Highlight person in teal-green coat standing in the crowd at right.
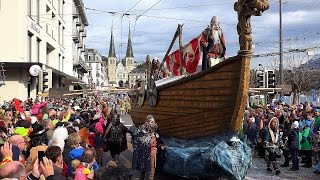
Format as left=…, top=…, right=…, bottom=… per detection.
left=300, top=120, right=312, bottom=168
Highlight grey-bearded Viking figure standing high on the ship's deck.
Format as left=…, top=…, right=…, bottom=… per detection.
left=200, top=16, right=226, bottom=70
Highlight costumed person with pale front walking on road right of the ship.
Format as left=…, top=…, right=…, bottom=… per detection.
left=263, top=117, right=281, bottom=175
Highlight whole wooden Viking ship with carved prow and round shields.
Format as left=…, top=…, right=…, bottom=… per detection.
left=130, top=0, right=269, bottom=139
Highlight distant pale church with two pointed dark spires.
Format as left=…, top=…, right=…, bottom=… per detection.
left=108, top=28, right=135, bottom=86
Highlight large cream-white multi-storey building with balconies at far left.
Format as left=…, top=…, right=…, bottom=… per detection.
left=0, top=0, right=88, bottom=100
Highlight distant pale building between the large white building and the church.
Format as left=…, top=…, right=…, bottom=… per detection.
left=85, top=49, right=106, bottom=90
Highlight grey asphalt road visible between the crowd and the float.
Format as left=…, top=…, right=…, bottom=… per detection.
left=113, top=114, right=320, bottom=180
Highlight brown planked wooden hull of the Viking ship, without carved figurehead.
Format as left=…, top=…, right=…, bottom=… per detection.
left=130, top=56, right=250, bottom=138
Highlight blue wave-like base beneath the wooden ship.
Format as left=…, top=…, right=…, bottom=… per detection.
left=162, top=135, right=252, bottom=179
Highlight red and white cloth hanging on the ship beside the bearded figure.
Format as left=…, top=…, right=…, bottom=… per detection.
left=165, top=36, right=201, bottom=76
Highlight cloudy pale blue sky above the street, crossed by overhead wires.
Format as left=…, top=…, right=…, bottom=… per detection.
left=84, top=0, right=320, bottom=68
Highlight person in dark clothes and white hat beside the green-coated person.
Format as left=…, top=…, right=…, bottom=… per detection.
left=288, top=121, right=300, bottom=171
